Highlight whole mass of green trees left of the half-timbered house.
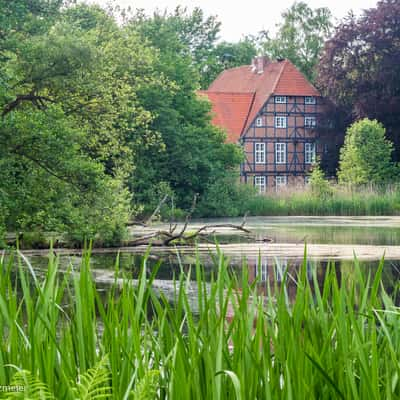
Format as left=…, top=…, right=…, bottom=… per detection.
left=0, top=0, right=241, bottom=242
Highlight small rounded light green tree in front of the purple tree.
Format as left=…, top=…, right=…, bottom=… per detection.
left=338, top=119, right=396, bottom=185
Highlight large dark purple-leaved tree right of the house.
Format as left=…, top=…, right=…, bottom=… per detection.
left=317, top=0, right=400, bottom=161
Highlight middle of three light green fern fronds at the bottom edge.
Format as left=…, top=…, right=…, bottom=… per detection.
left=75, top=357, right=111, bottom=400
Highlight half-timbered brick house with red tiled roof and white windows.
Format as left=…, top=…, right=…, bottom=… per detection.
left=202, top=57, right=323, bottom=192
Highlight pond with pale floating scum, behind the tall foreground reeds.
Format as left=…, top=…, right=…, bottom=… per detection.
left=12, top=217, right=400, bottom=302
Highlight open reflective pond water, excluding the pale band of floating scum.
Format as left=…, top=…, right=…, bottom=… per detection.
left=20, top=217, right=400, bottom=291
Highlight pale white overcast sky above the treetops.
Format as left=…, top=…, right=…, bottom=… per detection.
left=86, top=0, right=377, bottom=41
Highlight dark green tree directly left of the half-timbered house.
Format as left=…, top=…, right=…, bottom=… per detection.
left=130, top=10, right=242, bottom=209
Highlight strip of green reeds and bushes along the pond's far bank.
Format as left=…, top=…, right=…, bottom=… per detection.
left=202, top=184, right=400, bottom=217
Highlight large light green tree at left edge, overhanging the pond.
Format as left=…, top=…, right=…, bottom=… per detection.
left=0, top=1, right=159, bottom=241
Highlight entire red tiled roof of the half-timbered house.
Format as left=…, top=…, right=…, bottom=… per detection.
left=202, top=60, right=321, bottom=141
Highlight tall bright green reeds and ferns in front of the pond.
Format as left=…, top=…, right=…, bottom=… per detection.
left=0, top=254, right=400, bottom=399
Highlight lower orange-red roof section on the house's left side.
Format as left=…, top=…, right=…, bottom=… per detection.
left=199, top=90, right=254, bottom=143
